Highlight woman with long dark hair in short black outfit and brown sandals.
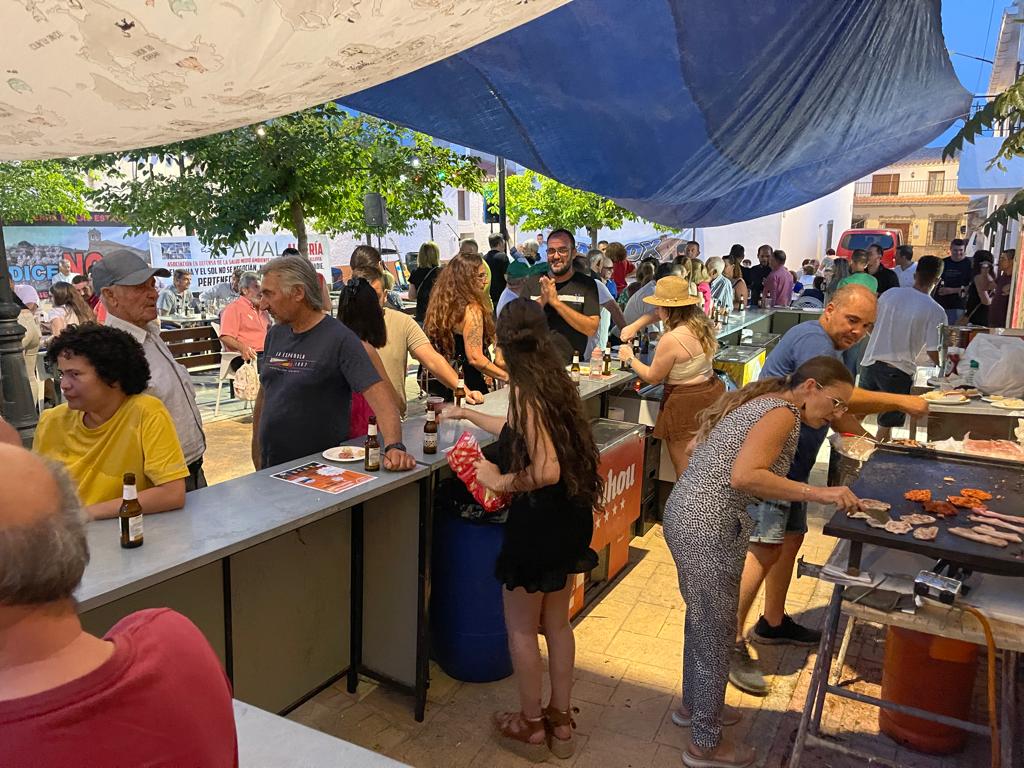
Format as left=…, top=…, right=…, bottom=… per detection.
left=442, top=299, right=603, bottom=758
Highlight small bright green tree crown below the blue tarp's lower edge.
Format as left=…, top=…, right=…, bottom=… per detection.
left=484, top=171, right=638, bottom=246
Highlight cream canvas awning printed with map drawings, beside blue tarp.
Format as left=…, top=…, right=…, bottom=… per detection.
left=0, top=0, right=568, bottom=161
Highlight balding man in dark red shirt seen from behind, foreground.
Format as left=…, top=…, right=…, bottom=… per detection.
left=0, top=444, right=238, bottom=767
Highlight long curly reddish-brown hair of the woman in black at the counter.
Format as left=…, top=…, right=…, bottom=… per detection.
left=423, top=252, right=495, bottom=357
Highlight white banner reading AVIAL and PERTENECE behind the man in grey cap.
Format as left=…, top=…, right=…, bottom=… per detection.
left=150, top=232, right=331, bottom=291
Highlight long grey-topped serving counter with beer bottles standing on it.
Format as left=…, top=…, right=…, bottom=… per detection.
left=76, top=310, right=816, bottom=720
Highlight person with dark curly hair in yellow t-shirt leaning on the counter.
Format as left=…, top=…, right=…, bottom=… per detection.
left=33, top=323, right=188, bottom=519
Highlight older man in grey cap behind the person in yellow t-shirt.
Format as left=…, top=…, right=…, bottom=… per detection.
left=91, top=250, right=206, bottom=490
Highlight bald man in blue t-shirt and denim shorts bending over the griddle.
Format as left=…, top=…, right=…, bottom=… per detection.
left=729, top=284, right=928, bottom=695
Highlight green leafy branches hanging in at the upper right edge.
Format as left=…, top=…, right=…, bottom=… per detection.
left=942, top=82, right=1024, bottom=234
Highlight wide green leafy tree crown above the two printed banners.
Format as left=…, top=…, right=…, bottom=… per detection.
left=83, top=102, right=483, bottom=254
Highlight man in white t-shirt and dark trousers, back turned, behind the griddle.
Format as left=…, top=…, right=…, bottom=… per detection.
left=860, top=256, right=946, bottom=440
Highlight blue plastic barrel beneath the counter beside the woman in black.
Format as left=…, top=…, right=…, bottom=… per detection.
left=430, top=495, right=512, bottom=683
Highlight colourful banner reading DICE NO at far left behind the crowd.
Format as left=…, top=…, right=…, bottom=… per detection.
left=3, top=218, right=150, bottom=298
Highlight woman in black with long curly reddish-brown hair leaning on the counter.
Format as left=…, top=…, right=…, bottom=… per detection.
left=423, top=252, right=508, bottom=399
